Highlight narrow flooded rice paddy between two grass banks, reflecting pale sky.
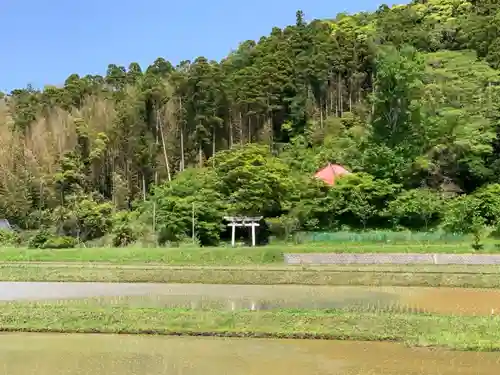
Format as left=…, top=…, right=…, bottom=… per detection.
left=0, top=282, right=500, bottom=315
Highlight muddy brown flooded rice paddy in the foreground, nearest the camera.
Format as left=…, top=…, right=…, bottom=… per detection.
left=0, top=333, right=500, bottom=375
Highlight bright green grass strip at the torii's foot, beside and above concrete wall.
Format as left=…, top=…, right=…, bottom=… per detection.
left=0, top=243, right=494, bottom=266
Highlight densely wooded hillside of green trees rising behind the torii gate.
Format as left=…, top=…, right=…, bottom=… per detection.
left=0, top=0, right=500, bottom=247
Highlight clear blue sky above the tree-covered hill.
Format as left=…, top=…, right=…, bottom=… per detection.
left=0, top=0, right=398, bottom=91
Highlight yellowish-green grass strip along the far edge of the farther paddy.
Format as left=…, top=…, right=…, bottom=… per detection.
left=0, top=264, right=500, bottom=288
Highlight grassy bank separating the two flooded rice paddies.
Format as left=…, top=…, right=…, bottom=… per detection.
left=0, top=303, right=500, bottom=351
